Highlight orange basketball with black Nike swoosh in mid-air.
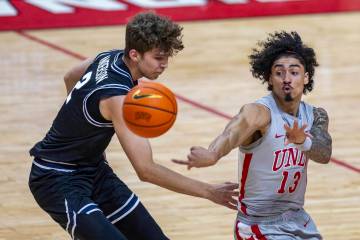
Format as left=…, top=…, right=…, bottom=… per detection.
left=123, top=82, right=177, bottom=138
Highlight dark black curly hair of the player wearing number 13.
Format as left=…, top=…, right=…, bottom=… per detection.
left=249, top=31, right=319, bottom=94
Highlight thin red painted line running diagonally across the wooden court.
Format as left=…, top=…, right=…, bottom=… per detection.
left=16, top=31, right=360, bottom=173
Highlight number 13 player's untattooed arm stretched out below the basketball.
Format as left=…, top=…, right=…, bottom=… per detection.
left=173, top=103, right=271, bottom=169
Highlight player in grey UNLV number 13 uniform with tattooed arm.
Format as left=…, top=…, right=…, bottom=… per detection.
left=173, top=32, right=332, bottom=240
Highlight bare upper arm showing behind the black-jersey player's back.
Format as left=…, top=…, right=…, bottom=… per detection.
left=64, top=58, right=94, bottom=94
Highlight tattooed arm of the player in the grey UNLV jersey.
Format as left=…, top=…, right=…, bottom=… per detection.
left=306, top=108, right=332, bottom=163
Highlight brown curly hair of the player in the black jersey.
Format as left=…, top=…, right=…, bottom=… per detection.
left=124, top=12, right=184, bottom=57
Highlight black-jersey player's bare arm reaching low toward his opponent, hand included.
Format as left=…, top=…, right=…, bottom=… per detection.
left=100, top=96, right=239, bottom=210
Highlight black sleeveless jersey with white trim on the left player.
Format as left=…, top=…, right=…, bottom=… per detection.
left=30, top=50, right=137, bottom=165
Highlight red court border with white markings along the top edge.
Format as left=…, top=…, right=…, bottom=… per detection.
left=0, top=0, right=360, bottom=30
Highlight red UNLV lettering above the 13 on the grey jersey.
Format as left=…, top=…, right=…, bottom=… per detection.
left=272, top=148, right=306, bottom=172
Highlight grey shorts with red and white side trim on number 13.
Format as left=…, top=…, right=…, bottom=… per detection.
left=234, top=209, right=322, bottom=240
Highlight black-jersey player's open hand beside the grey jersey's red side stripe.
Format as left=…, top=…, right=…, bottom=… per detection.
left=208, top=182, right=239, bottom=210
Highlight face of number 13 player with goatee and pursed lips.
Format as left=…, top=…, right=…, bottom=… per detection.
left=269, top=56, right=309, bottom=102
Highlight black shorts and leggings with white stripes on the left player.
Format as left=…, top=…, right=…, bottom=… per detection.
left=29, top=158, right=168, bottom=240
